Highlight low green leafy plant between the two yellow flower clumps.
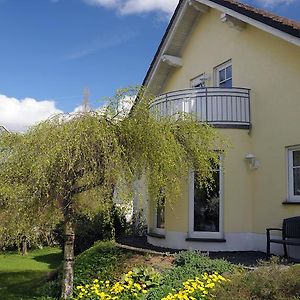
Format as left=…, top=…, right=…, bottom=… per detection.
left=147, top=251, right=236, bottom=300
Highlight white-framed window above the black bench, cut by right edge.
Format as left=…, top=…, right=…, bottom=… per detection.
left=288, top=146, right=300, bottom=202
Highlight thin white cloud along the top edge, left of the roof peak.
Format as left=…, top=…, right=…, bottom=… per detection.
left=84, top=0, right=178, bottom=14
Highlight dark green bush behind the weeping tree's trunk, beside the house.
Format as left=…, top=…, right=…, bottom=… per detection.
left=54, top=207, right=126, bottom=255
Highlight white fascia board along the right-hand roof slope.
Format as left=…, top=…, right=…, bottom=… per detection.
left=195, top=0, right=300, bottom=46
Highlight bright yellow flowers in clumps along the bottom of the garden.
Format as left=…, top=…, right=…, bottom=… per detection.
left=74, top=268, right=227, bottom=300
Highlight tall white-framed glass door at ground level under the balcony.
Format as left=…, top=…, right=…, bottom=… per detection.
left=189, top=162, right=223, bottom=239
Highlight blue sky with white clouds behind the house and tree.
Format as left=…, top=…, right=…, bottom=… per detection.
left=0, top=0, right=300, bottom=130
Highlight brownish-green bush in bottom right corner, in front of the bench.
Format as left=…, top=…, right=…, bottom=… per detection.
left=216, top=262, right=300, bottom=300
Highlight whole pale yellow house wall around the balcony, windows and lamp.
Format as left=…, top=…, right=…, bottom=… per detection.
left=149, top=9, right=300, bottom=233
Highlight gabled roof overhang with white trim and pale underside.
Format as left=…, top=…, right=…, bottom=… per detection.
left=143, top=0, right=300, bottom=94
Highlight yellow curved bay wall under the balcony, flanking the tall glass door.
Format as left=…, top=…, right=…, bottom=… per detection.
left=158, top=129, right=253, bottom=232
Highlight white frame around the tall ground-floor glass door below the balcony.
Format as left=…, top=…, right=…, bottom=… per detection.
left=188, top=155, right=224, bottom=239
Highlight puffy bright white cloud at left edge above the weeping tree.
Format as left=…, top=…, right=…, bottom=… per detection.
left=0, top=94, right=62, bottom=131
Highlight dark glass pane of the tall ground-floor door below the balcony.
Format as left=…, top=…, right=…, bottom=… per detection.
left=194, top=171, right=220, bottom=232
